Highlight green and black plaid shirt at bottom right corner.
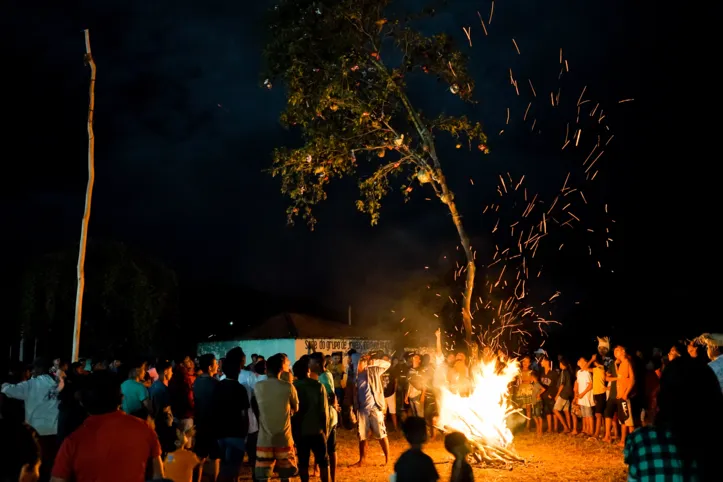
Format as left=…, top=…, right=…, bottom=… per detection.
left=625, top=426, right=697, bottom=482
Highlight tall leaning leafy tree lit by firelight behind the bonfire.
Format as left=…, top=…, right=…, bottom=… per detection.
left=264, top=0, right=489, bottom=342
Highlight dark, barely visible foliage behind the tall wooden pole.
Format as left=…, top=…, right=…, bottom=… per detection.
left=21, top=242, right=177, bottom=355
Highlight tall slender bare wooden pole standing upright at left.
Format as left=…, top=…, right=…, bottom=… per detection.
left=73, top=29, right=96, bottom=362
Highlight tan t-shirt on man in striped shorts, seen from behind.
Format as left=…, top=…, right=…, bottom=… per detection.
left=254, top=378, right=299, bottom=448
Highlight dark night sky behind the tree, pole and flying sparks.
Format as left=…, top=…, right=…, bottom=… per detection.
left=0, top=0, right=700, bottom=350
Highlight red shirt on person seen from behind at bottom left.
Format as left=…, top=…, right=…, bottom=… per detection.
left=52, top=410, right=161, bottom=482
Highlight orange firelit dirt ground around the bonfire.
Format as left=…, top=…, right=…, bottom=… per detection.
left=235, top=430, right=627, bottom=482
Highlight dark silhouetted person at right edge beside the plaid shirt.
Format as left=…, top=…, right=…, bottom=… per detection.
left=655, top=357, right=723, bottom=481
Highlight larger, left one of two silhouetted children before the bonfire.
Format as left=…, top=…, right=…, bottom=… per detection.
left=390, top=417, right=439, bottom=482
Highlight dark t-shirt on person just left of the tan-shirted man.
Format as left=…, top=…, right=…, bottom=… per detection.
left=214, top=378, right=249, bottom=438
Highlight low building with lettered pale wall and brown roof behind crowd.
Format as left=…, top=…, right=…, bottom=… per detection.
left=198, top=313, right=392, bottom=361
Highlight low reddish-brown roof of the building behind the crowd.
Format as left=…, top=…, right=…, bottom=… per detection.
left=239, top=313, right=368, bottom=340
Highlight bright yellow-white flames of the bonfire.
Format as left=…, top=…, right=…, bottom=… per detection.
left=437, top=357, right=520, bottom=449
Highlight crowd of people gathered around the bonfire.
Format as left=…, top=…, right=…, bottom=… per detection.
left=0, top=331, right=723, bottom=482
